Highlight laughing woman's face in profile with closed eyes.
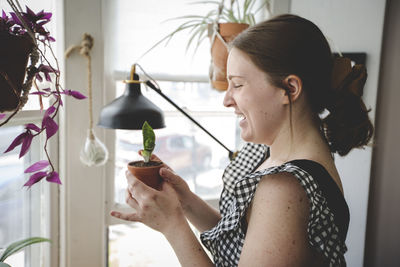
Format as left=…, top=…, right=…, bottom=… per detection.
left=224, top=48, right=287, bottom=145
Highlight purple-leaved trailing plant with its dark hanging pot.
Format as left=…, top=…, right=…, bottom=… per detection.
left=0, top=3, right=86, bottom=187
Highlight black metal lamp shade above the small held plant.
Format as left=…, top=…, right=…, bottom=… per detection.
left=98, top=79, right=165, bottom=130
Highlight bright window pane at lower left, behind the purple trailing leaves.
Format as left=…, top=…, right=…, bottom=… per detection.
left=0, top=118, right=50, bottom=267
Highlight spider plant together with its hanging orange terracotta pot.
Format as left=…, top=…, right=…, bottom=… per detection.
left=143, top=0, right=270, bottom=91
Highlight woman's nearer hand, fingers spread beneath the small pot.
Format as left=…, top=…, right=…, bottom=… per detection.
left=111, top=171, right=186, bottom=234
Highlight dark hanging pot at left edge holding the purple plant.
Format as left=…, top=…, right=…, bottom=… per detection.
left=0, top=32, right=34, bottom=112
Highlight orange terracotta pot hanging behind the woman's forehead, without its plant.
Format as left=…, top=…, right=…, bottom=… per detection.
left=208, top=23, right=249, bottom=91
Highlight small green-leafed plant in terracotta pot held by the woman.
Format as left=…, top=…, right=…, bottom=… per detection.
left=128, top=121, right=164, bottom=190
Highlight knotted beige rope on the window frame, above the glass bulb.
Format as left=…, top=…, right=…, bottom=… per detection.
left=65, top=33, right=94, bottom=140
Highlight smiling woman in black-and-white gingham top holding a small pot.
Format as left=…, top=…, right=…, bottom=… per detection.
left=112, top=15, right=373, bottom=267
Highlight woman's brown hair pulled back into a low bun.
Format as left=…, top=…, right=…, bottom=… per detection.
left=231, top=14, right=374, bottom=156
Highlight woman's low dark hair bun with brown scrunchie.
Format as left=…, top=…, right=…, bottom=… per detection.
left=322, top=58, right=374, bottom=156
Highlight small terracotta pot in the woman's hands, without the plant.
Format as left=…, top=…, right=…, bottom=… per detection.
left=128, top=160, right=164, bottom=190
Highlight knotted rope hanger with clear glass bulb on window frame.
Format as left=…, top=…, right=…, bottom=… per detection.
left=65, top=33, right=108, bottom=166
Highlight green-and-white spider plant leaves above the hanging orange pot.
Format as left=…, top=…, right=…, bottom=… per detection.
left=140, top=0, right=270, bottom=58
